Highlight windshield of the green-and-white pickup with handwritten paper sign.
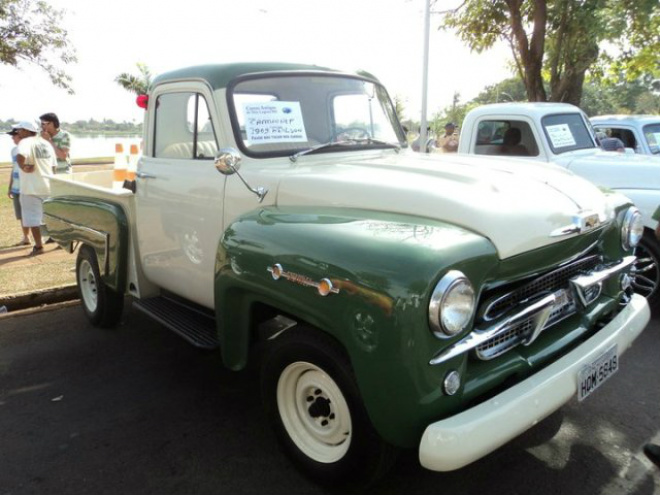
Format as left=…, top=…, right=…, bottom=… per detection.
left=227, top=73, right=405, bottom=157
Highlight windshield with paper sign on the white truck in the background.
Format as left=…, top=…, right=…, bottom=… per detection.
left=541, top=113, right=596, bottom=155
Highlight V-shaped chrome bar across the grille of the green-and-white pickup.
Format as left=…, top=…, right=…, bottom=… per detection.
left=429, top=294, right=557, bottom=366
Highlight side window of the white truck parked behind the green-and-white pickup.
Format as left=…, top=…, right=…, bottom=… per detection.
left=474, top=120, right=539, bottom=156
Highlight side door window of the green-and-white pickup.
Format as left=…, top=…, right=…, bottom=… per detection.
left=154, top=92, right=218, bottom=160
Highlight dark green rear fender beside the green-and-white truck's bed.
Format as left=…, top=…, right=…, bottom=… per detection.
left=44, top=196, right=129, bottom=293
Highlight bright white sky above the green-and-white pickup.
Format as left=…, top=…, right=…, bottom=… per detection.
left=0, top=0, right=511, bottom=122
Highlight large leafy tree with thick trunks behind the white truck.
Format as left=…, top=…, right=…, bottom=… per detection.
left=441, top=0, right=660, bottom=105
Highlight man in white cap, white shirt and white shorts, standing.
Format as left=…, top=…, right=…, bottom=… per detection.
left=12, top=121, right=57, bottom=256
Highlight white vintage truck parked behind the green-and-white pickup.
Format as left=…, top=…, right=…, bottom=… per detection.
left=458, top=103, right=660, bottom=306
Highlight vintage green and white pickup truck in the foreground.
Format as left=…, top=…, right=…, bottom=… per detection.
left=45, top=64, right=649, bottom=483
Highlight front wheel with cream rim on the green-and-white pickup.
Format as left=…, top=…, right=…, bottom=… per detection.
left=261, top=328, right=398, bottom=486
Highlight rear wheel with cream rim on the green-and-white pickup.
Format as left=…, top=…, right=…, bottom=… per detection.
left=76, top=246, right=124, bottom=328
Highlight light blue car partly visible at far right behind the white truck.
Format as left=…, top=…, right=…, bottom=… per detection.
left=591, top=115, right=660, bottom=156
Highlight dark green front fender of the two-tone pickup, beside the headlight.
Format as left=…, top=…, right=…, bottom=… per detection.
left=215, top=208, right=497, bottom=446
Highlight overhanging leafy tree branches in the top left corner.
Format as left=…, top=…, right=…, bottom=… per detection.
left=0, top=0, right=77, bottom=94
